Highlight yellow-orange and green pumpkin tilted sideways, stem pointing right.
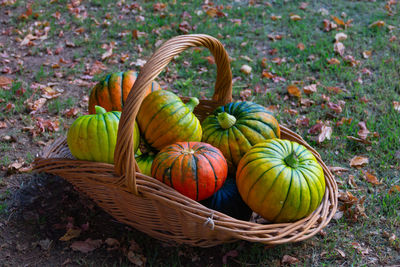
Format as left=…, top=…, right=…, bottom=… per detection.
left=137, top=90, right=202, bottom=151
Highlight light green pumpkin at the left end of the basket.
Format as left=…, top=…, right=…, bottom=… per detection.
left=67, top=106, right=140, bottom=163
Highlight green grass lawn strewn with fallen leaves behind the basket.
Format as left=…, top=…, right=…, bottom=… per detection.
left=0, top=0, right=400, bottom=266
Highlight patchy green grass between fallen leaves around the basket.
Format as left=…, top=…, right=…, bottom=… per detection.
left=0, top=0, right=400, bottom=266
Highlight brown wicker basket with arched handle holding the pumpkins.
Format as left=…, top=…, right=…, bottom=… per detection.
left=34, top=34, right=338, bottom=247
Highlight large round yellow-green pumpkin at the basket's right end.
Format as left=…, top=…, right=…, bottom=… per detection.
left=236, top=139, right=325, bottom=223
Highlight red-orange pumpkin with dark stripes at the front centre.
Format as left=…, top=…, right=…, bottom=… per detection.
left=151, top=142, right=228, bottom=201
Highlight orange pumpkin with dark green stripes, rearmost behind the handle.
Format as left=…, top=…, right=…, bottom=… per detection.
left=89, top=70, right=161, bottom=114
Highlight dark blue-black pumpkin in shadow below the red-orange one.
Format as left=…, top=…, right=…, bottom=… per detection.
left=200, top=178, right=253, bottom=221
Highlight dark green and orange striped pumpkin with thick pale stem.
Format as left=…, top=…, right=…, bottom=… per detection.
left=201, top=102, right=280, bottom=167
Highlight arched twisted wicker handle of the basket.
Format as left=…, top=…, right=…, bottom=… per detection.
left=114, top=34, right=232, bottom=195
